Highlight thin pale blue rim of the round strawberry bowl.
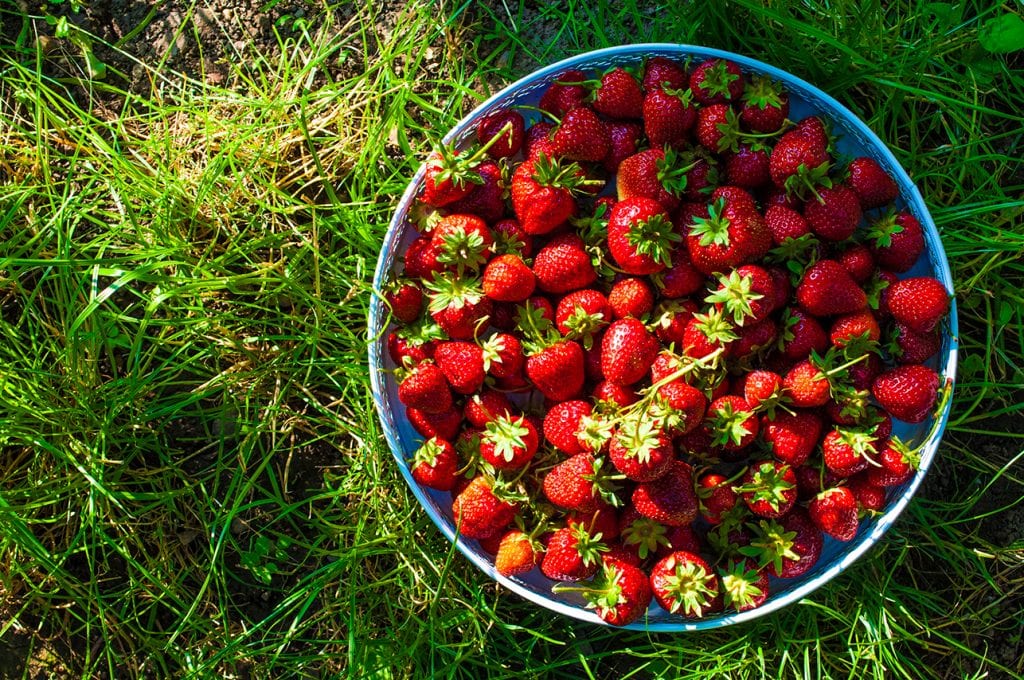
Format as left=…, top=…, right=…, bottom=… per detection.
left=368, top=43, right=958, bottom=633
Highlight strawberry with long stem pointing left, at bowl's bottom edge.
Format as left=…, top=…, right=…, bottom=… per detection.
left=552, top=552, right=651, bottom=626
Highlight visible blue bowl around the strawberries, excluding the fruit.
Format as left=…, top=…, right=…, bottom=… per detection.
left=369, top=43, right=957, bottom=632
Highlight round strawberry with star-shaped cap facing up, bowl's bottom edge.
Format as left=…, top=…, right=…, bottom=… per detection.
left=650, top=550, right=719, bottom=619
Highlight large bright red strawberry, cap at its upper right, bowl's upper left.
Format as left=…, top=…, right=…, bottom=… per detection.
left=512, top=153, right=585, bottom=235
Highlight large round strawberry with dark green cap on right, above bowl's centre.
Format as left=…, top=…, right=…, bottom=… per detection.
left=607, top=196, right=679, bottom=274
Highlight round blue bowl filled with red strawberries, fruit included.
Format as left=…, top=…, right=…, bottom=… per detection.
left=369, top=44, right=956, bottom=631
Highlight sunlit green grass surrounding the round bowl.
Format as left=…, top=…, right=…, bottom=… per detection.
left=0, top=0, right=1024, bottom=678
